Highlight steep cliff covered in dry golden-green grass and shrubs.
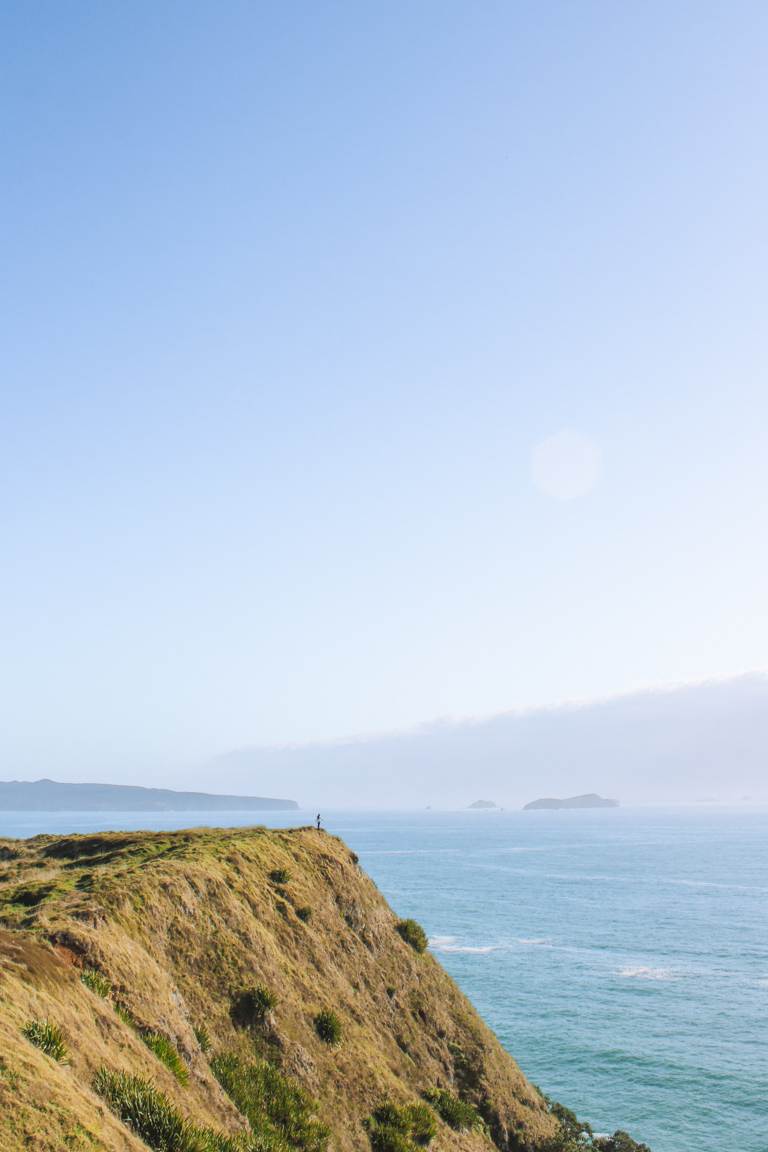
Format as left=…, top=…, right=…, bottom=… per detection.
left=0, top=828, right=649, bottom=1152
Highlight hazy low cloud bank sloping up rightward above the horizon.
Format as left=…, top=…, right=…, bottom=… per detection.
left=202, top=674, right=768, bottom=808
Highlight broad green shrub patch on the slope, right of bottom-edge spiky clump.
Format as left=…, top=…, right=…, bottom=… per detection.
left=211, top=1053, right=330, bottom=1152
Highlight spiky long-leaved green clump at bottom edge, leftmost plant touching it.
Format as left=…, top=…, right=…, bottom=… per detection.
left=93, top=1068, right=249, bottom=1152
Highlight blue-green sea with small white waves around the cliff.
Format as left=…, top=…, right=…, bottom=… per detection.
left=0, top=808, right=768, bottom=1152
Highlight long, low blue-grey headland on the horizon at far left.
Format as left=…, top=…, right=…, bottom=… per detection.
left=0, top=780, right=298, bottom=812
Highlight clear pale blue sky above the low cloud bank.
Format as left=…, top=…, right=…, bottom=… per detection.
left=0, top=0, right=768, bottom=779
